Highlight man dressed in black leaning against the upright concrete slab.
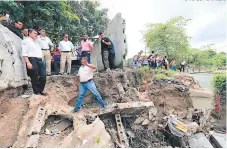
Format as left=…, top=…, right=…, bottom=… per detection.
left=100, top=33, right=115, bottom=71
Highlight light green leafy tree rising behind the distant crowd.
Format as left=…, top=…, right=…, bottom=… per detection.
left=144, top=17, right=189, bottom=61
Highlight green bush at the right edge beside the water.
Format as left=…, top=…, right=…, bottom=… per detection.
left=211, top=73, right=226, bottom=93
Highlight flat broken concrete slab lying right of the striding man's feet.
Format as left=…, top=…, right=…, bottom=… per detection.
left=98, top=102, right=154, bottom=117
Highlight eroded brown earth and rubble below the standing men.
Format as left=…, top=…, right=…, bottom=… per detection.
left=0, top=69, right=224, bottom=147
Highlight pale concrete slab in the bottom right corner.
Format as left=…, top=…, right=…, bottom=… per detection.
left=210, top=131, right=227, bottom=148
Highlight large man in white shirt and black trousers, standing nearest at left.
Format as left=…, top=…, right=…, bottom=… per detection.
left=22, top=29, right=47, bottom=96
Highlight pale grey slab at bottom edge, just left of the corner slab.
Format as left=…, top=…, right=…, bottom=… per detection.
left=188, top=133, right=213, bottom=148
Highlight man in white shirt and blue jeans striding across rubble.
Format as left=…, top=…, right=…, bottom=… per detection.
left=72, top=56, right=106, bottom=113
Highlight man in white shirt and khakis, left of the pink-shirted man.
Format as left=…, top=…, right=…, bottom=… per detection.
left=58, top=34, right=74, bottom=75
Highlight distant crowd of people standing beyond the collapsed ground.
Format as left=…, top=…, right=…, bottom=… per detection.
left=133, top=50, right=186, bottom=72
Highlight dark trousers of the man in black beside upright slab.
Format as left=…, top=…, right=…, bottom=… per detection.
left=102, top=49, right=115, bottom=69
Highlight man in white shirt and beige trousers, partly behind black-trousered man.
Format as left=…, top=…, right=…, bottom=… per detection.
left=37, top=28, right=54, bottom=76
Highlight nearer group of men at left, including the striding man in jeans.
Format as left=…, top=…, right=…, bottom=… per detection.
left=1, top=17, right=115, bottom=112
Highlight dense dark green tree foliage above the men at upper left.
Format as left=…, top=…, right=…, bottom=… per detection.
left=0, top=1, right=109, bottom=43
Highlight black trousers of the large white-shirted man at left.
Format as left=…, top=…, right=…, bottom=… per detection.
left=27, top=57, right=46, bottom=94
